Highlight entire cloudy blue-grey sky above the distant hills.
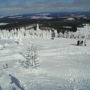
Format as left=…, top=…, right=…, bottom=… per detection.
left=0, top=0, right=90, bottom=16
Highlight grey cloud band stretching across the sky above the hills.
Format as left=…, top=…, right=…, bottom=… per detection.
left=0, top=0, right=90, bottom=15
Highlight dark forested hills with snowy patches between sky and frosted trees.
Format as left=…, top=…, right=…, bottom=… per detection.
left=0, top=11, right=90, bottom=32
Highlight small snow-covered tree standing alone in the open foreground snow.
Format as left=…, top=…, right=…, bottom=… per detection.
left=23, top=45, right=39, bottom=68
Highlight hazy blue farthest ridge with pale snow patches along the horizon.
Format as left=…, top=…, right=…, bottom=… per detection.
left=0, top=11, right=90, bottom=19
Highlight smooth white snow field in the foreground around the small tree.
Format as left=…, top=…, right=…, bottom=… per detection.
left=0, top=38, right=90, bottom=90
